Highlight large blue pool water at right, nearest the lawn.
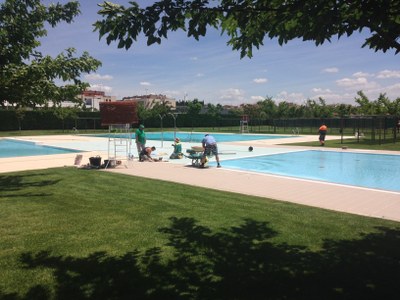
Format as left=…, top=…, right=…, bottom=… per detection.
left=210, top=150, right=400, bottom=192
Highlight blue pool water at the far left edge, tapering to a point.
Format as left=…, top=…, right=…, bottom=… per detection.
left=0, top=139, right=82, bottom=158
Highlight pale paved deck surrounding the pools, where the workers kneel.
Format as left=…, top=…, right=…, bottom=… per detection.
left=0, top=135, right=400, bottom=222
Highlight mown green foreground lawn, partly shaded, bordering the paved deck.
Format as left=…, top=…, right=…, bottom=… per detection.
left=0, top=168, right=400, bottom=299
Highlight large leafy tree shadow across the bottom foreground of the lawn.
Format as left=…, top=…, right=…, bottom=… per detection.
left=0, top=218, right=400, bottom=299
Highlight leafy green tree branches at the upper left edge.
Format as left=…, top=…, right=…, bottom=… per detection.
left=0, top=0, right=101, bottom=107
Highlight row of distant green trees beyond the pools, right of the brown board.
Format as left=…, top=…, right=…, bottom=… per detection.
left=139, top=91, right=400, bottom=127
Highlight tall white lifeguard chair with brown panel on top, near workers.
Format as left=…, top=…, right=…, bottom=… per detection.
left=100, top=101, right=139, bottom=168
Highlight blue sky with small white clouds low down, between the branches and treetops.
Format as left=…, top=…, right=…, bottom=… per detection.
left=39, top=0, right=400, bottom=105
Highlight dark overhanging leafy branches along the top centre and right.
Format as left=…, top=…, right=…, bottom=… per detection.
left=95, top=0, right=400, bottom=57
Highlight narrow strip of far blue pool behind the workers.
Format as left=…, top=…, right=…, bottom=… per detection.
left=90, top=131, right=291, bottom=143
